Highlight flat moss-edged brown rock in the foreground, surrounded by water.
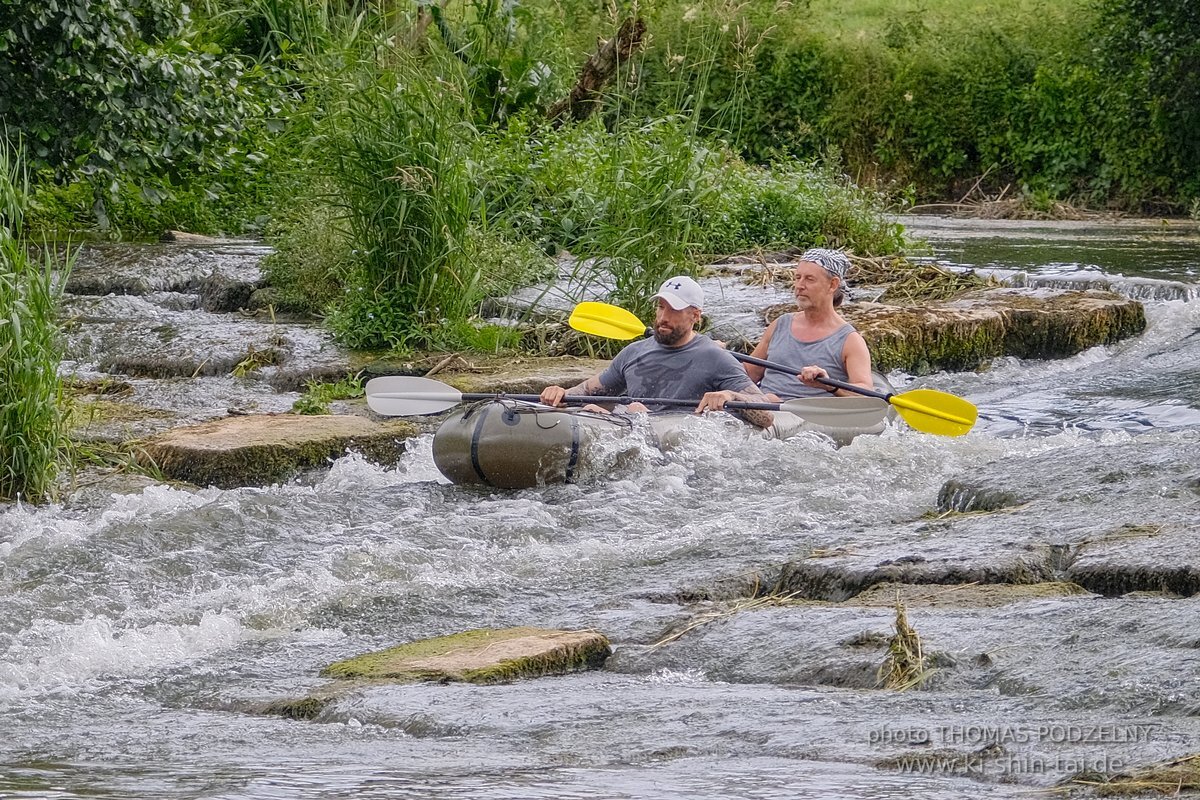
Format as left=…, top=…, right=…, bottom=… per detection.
left=320, top=627, right=611, bottom=684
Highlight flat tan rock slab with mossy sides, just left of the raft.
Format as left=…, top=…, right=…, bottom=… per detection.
left=138, top=414, right=418, bottom=488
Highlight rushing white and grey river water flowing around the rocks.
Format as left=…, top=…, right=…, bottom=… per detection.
left=0, top=218, right=1200, bottom=799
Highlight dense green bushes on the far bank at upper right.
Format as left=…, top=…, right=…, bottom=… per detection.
left=638, top=0, right=1200, bottom=210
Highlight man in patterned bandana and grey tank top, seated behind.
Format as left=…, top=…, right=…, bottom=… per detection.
left=744, top=247, right=874, bottom=402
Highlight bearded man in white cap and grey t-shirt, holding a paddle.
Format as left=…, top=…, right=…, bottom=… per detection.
left=541, top=275, right=773, bottom=428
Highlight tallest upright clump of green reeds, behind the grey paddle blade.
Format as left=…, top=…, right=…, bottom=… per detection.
left=316, top=58, right=480, bottom=348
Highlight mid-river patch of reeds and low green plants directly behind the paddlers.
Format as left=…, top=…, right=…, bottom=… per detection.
left=268, top=56, right=902, bottom=349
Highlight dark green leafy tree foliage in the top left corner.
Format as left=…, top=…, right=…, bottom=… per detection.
left=0, top=0, right=264, bottom=222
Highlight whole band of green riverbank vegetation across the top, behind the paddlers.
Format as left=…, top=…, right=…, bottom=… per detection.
left=0, top=0, right=1200, bottom=349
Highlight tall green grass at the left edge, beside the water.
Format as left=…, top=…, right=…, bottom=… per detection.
left=0, top=136, right=66, bottom=503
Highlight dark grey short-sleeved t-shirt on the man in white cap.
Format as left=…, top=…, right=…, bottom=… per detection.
left=600, top=333, right=754, bottom=411
